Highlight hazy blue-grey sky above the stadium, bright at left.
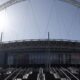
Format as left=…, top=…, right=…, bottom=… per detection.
left=0, top=0, right=80, bottom=41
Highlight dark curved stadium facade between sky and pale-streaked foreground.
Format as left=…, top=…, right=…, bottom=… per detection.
left=0, top=39, right=80, bottom=66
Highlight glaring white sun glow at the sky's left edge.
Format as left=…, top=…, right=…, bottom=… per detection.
left=0, top=11, right=9, bottom=33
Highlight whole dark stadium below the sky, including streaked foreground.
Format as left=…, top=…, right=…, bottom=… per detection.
left=0, top=39, right=80, bottom=80
